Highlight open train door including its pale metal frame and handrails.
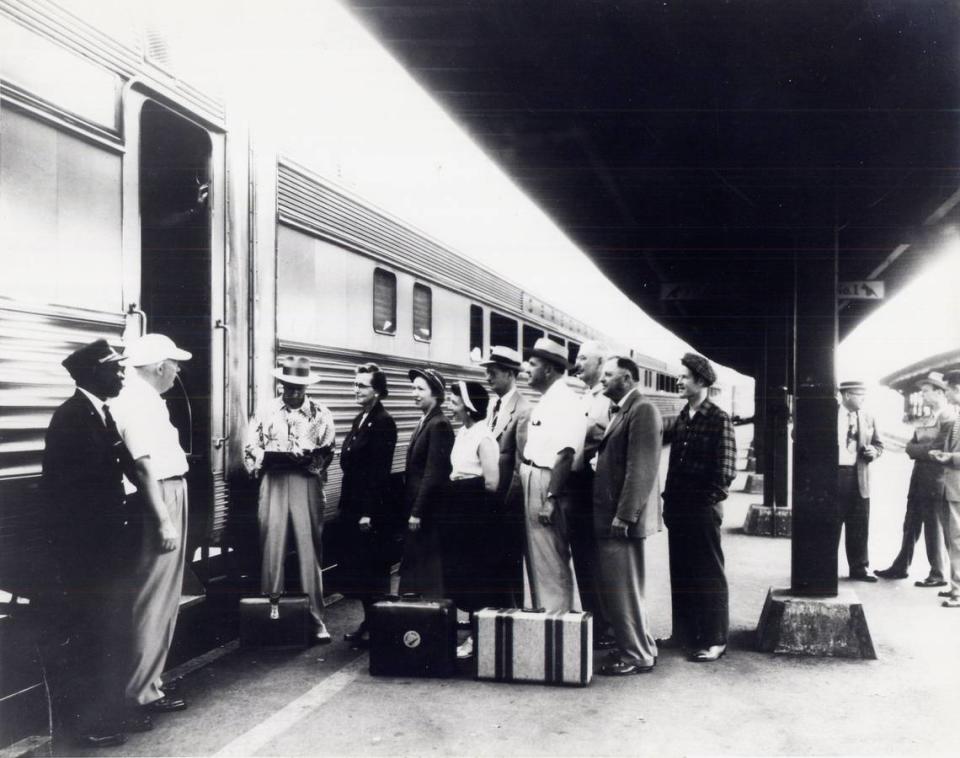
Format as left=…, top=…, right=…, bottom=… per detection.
left=124, top=89, right=229, bottom=595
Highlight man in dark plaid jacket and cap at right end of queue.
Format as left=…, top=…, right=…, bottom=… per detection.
left=662, top=353, right=737, bottom=663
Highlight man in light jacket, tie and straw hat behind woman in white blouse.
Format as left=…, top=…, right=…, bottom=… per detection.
left=480, top=345, right=532, bottom=608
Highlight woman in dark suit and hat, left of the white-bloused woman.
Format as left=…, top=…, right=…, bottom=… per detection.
left=400, top=368, right=453, bottom=598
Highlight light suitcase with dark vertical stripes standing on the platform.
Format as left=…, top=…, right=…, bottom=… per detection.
left=473, top=608, right=593, bottom=686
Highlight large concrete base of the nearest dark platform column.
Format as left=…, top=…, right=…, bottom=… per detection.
left=757, top=587, right=877, bottom=660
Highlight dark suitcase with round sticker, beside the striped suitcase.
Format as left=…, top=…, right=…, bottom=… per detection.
left=367, top=595, right=457, bottom=677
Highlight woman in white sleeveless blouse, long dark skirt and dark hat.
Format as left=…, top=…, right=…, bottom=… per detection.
left=441, top=381, right=500, bottom=658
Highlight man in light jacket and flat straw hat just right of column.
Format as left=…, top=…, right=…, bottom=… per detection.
left=837, top=381, right=883, bottom=582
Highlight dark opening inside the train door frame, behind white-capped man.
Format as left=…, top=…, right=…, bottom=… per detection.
left=139, top=100, right=223, bottom=556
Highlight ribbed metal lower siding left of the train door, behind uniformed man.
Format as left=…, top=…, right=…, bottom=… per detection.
left=0, top=300, right=123, bottom=589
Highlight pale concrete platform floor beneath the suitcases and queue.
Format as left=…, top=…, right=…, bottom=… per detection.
left=73, top=453, right=960, bottom=757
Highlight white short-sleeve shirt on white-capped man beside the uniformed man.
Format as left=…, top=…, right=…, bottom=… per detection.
left=110, top=371, right=189, bottom=479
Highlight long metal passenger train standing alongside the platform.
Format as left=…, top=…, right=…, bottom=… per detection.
left=0, top=0, right=752, bottom=744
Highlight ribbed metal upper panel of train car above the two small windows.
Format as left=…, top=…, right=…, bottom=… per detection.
left=277, top=163, right=523, bottom=320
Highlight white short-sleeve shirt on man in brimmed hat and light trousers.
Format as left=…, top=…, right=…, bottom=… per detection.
left=521, top=379, right=587, bottom=468
